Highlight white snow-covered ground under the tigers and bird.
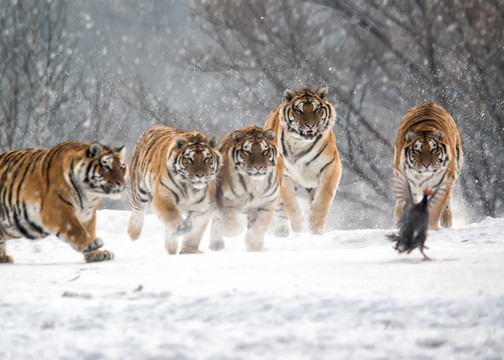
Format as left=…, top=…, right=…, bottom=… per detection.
left=0, top=210, right=504, bottom=360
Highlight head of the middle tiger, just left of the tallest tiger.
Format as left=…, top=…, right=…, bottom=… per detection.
left=231, top=126, right=278, bottom=178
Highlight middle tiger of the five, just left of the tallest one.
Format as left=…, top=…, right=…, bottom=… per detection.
left=210, top=126, right=283, bottom=251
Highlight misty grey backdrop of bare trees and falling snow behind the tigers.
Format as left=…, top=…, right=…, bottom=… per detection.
left=0, top=0, right=504, bottom=230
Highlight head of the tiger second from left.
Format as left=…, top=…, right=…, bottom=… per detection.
left=167, top=131, right=221, bottom=189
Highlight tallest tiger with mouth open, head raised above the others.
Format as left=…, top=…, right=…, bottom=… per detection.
left=264, top=87, right=341, bottom=236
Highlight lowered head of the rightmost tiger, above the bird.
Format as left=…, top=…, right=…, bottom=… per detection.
left=404, top=130, right=449, bottom=173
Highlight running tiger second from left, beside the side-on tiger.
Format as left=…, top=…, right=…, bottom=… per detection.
left=128, top=125, right=222, bottom=255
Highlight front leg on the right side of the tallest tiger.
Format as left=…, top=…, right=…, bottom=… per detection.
left=309, top=159, right=341, bottom=235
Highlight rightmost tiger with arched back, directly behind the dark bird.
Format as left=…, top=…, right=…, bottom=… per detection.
left=394, top=103, right=463, bottom=229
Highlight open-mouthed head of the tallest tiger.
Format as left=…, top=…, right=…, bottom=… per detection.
left=283, top=87, right=336, bottom=140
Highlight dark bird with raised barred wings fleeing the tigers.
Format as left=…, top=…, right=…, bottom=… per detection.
left=387, top=169, right=447, bottom=260
